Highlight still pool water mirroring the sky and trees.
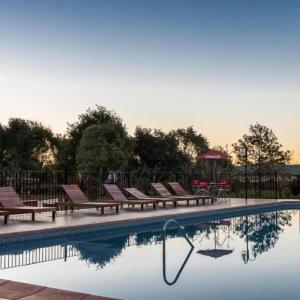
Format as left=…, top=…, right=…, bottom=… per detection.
left=0, top=210, right=300, bottom=300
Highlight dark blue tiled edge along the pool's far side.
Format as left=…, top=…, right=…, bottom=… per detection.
left=0, top=200, right=300, bottom=244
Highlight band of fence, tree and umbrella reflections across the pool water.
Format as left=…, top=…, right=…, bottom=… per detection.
left=0, top=211, right=293, bottom=270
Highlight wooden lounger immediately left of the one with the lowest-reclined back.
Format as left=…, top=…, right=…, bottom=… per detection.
left=103, top=184, right=158, bottom=210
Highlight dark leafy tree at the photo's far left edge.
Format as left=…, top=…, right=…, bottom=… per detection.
left=0, top=118, right=56, bottom=169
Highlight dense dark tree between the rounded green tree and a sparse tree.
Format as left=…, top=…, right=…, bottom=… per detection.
left=135, top=127, right=191, bottom=172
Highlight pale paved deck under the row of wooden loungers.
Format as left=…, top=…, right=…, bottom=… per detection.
left=0, top=199, right=300, bottom=237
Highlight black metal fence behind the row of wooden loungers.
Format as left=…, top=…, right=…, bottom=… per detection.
left=0, top=170, right=288, bottom=204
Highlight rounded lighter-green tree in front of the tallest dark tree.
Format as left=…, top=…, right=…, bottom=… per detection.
left=76, top=122, right=132, bottom=170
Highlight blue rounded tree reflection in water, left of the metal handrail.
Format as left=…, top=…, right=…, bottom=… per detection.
left=74, top=236, right=128, bottom=269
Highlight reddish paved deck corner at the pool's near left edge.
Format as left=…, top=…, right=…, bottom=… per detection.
left=0, top=279, right=116, bottom=300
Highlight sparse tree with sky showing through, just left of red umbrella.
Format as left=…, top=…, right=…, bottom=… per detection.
left=170, top=126, right=209, bottom=162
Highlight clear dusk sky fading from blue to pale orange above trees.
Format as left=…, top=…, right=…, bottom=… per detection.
left=0, top=0, right=300, bottom=163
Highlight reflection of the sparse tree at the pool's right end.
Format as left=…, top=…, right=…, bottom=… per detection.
left=235, top=211, right=292, bottom=262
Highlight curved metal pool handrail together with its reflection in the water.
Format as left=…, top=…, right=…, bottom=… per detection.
left=163, top=219, right=194, bottom=285
